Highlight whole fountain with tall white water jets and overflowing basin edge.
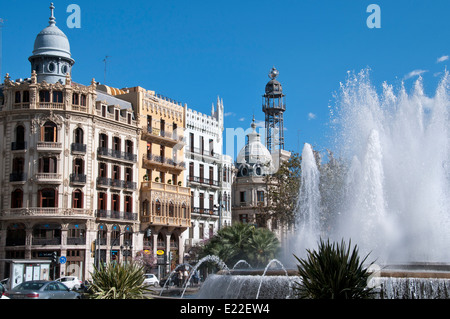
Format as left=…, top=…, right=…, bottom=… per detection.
left=180, top=70, right=450, bottom=299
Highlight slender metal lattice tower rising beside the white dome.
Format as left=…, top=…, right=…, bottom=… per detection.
left=262, top=67, right=286, bottom=153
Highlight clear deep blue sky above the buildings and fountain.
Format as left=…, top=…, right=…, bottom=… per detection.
left=0, top=0, right=450, bottom=160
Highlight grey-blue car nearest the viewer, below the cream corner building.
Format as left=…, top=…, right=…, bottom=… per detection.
left=6, top=280, right=81, bottom=299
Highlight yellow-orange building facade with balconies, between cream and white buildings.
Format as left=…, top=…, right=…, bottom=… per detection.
left=101, top=86, right=191, bottom=270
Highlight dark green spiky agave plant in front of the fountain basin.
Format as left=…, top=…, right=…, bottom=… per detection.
left=294, top=239, right=373, bottom=299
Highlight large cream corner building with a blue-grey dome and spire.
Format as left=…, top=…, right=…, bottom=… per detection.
left=0, top=4, right=142, bottom=280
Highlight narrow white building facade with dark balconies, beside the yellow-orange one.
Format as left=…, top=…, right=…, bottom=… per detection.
left=184, top=98, right=233, bottom=252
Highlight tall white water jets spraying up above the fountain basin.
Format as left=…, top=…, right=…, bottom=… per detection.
left=298, top=70, right=450, bottom=262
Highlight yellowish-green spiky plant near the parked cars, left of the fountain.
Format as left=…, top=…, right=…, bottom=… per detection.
left=91, top=263, right=151, bottom=299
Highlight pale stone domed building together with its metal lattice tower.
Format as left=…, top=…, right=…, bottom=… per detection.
left=232, top=68, right=291, bottom=237
